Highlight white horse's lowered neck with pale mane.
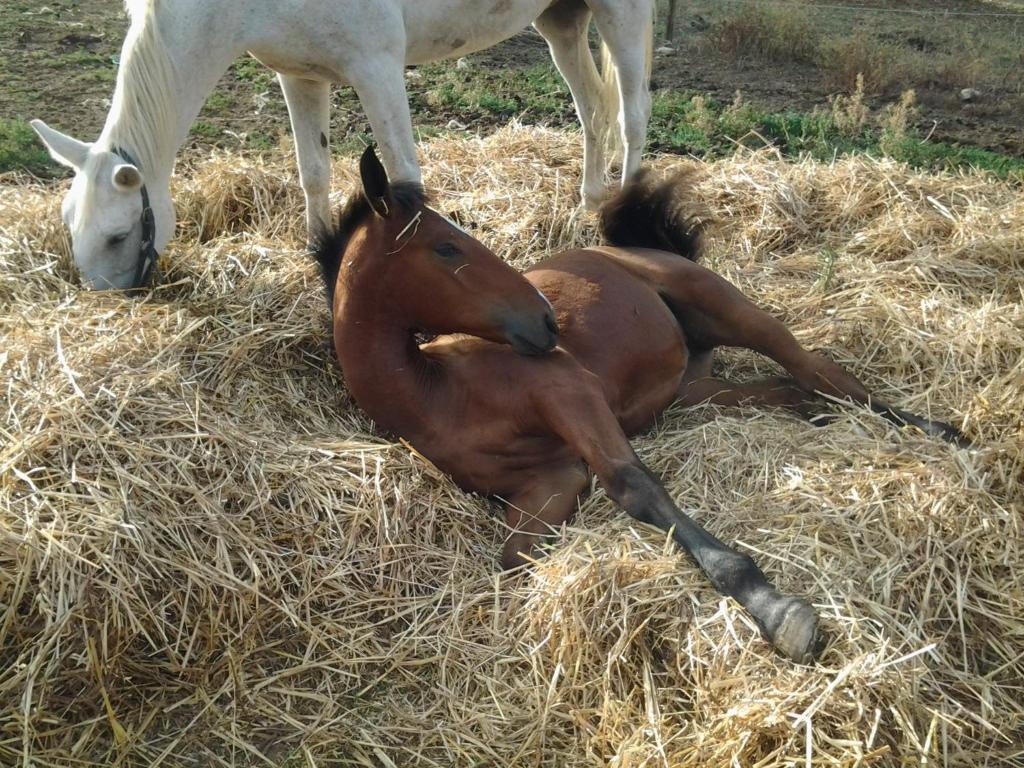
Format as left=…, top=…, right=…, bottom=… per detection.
left=97, top=0, right=237, bottom=184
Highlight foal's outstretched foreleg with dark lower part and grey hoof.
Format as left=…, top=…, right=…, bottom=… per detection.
left=537, top=371, right=820, bottom=664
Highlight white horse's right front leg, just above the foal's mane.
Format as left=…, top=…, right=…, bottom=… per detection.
left=347, top=56, right=422, bottom=183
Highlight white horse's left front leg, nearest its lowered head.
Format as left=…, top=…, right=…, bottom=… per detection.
left=278, top=75, right=331, bottom=243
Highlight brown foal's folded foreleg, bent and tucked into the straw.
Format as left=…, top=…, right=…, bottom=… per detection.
left=502, top=461, right=590, bottom=570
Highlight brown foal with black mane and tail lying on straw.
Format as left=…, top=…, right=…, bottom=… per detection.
left=316, top=148, right=963, bottom=663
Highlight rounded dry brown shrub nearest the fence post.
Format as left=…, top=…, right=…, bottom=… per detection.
left=708, top=3, right=821, bottom=63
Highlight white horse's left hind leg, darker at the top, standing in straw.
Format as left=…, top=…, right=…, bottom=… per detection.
left=534, top=2, right=608, bottom=210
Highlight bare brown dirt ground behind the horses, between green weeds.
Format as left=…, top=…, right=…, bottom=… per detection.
left=0, top=0, right=1024, bottom=167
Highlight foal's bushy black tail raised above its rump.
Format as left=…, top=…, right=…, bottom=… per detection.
left=598, top=168, right=705, bottom=261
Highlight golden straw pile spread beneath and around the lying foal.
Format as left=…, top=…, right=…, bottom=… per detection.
left=0, top=128, right=1024, bottom=768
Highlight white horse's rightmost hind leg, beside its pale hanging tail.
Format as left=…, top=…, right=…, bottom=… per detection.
left=589, top=0, right=652, bottom=183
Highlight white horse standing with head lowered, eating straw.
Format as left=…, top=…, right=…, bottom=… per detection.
left=32, top=0, right=653, bottom=289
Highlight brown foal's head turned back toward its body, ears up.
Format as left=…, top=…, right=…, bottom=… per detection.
left=316, top=147, right=558, bottom=354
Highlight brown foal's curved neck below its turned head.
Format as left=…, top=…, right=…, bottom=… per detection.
left=334, top=262, right=444, bottom=441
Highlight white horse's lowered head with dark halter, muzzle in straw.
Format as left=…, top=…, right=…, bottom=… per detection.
left=32, top=120, right=175, bottom=289
